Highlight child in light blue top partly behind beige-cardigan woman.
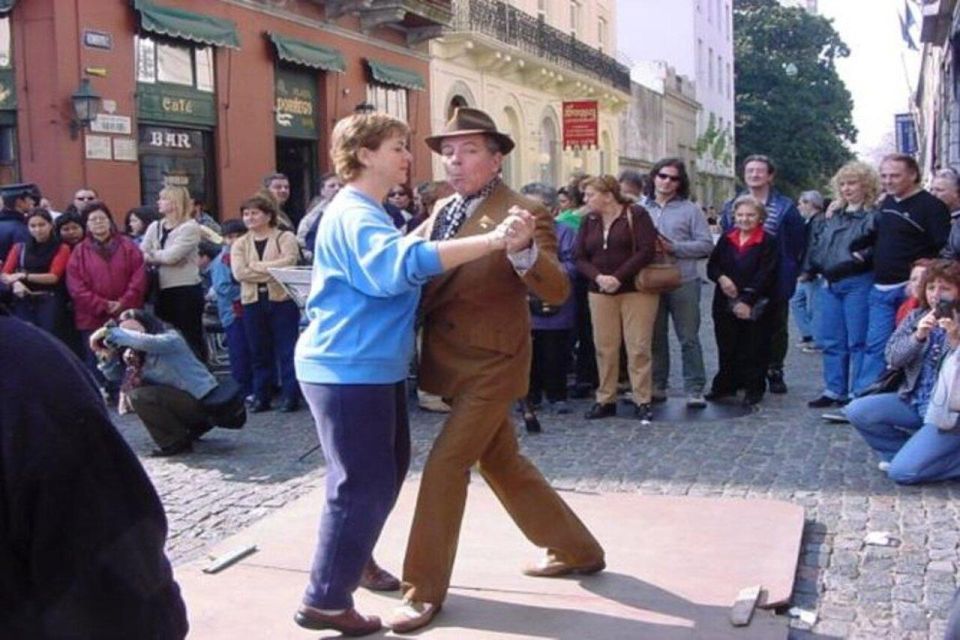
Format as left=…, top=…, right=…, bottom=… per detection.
left=209, top=220, right=253, bottom=396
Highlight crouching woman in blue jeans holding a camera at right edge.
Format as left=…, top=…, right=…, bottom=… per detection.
left=845, top=260, right=960, bottom=484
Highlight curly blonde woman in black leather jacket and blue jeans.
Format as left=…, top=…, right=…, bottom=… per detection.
left=804, top=162, right=880, bottom=408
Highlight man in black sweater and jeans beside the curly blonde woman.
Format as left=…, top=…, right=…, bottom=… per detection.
left=853, top=153, right=950, bottom=389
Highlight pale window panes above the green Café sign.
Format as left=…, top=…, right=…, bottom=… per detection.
left=136, top=36, right=214, bottom=93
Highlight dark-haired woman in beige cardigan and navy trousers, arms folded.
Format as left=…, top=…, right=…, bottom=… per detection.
left=230, top=195, right=300, bottom=413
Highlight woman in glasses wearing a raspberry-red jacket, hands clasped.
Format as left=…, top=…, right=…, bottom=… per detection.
left=67, top=201, right=147, bottom=386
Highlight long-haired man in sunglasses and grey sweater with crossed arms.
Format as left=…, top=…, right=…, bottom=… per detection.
left=642, top=158, right=713, bottom=408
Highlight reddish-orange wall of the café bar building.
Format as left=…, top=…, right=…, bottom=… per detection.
left=12, top=0, right=430, bottom=217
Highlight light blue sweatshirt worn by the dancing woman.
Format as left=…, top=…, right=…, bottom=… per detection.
left=295, top=185, right=443, bottom=384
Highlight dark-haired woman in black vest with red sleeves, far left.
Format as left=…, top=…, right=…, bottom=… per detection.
left=0, top=208, right=70, bottom=340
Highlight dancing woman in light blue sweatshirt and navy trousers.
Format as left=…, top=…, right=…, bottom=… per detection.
left=295, top=113, right=534, bottom=636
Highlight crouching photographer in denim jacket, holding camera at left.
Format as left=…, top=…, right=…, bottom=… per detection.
left=90, top=309, right=217, bottom=457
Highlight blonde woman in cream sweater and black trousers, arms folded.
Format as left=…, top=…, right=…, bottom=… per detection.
left=140, top=187, right=207, bottom=362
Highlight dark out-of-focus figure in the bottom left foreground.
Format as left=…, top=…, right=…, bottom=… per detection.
left=0, top=311, right=187, bottom=640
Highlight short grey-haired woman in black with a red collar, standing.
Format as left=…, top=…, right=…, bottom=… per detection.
left=707, top=196, right=779, bottom=405
